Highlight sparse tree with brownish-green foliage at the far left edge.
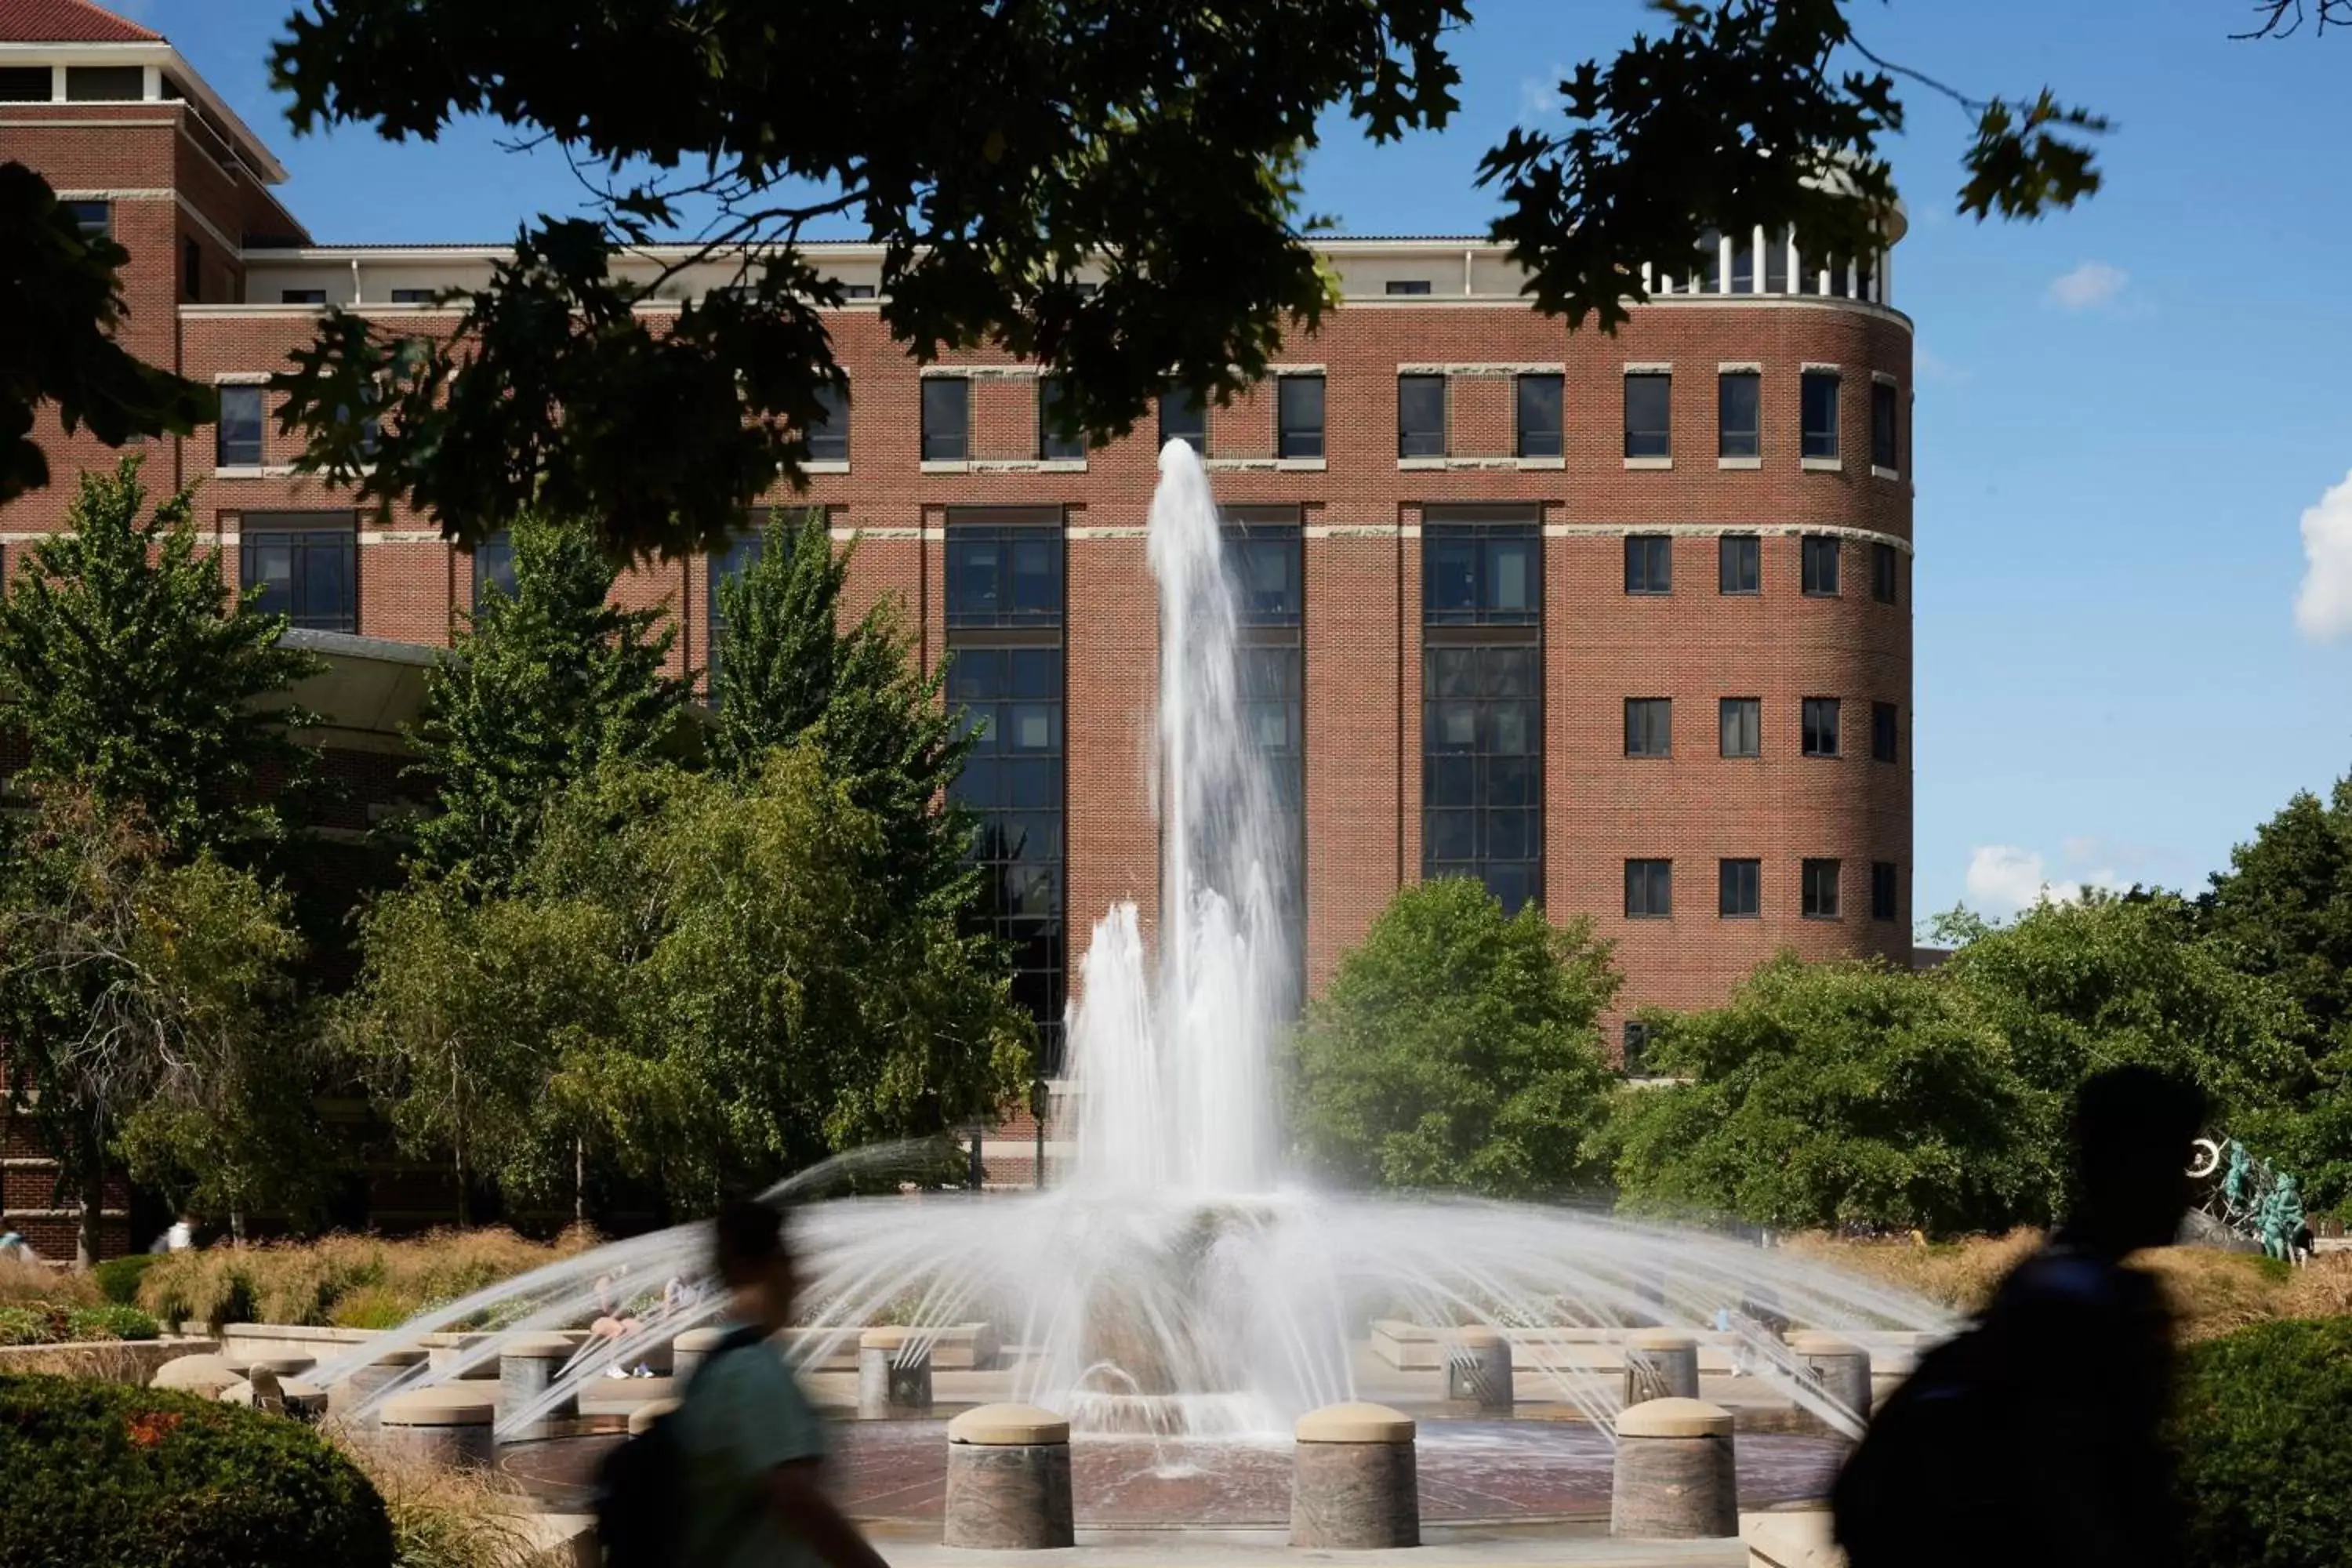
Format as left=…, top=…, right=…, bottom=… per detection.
left=0, top=785, right=299, bottom=1262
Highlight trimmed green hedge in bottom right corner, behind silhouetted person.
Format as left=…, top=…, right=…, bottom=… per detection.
left=2173, top=1316, right=2352, bottom=1568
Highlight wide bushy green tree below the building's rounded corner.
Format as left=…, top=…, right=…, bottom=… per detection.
left=1609, top=954, right=2051, bottom=1234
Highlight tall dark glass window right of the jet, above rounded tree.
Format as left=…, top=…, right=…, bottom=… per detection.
left=1421, top=508, right=1543, bottom=909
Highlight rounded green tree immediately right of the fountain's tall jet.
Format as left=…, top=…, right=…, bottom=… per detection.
left=1296, top=877, right=1618, bottom=1199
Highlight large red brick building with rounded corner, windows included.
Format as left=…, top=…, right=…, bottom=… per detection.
left=0, top=0, right=1912, bottom=1213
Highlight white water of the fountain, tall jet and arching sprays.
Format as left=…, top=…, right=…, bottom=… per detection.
left=318, top=442, right=1947, bottom=1521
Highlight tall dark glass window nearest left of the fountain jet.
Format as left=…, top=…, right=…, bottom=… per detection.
left=948, top=508, right=1068, bottom=1076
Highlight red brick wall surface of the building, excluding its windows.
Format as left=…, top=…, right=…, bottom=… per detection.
left=0, top=21, right=1912, bottom=1213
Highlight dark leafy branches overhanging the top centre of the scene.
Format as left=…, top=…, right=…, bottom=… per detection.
left=270, top=0, right=2100, bottom=553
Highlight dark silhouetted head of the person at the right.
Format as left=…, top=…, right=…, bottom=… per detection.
left=2067, top=1065, right=2206, bottom=1255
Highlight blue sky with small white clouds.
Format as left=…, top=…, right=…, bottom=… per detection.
left=118, top=0, right=2352, bottom=914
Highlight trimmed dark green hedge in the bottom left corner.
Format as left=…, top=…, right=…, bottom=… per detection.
left=0, top=1377, right=393, bottom=1568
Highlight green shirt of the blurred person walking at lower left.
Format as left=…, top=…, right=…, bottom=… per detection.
left=677, top=1345, right=826, bottom=1568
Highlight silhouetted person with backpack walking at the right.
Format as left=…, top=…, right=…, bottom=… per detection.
left=1835, top=1067, right=2204, bottom=1568
